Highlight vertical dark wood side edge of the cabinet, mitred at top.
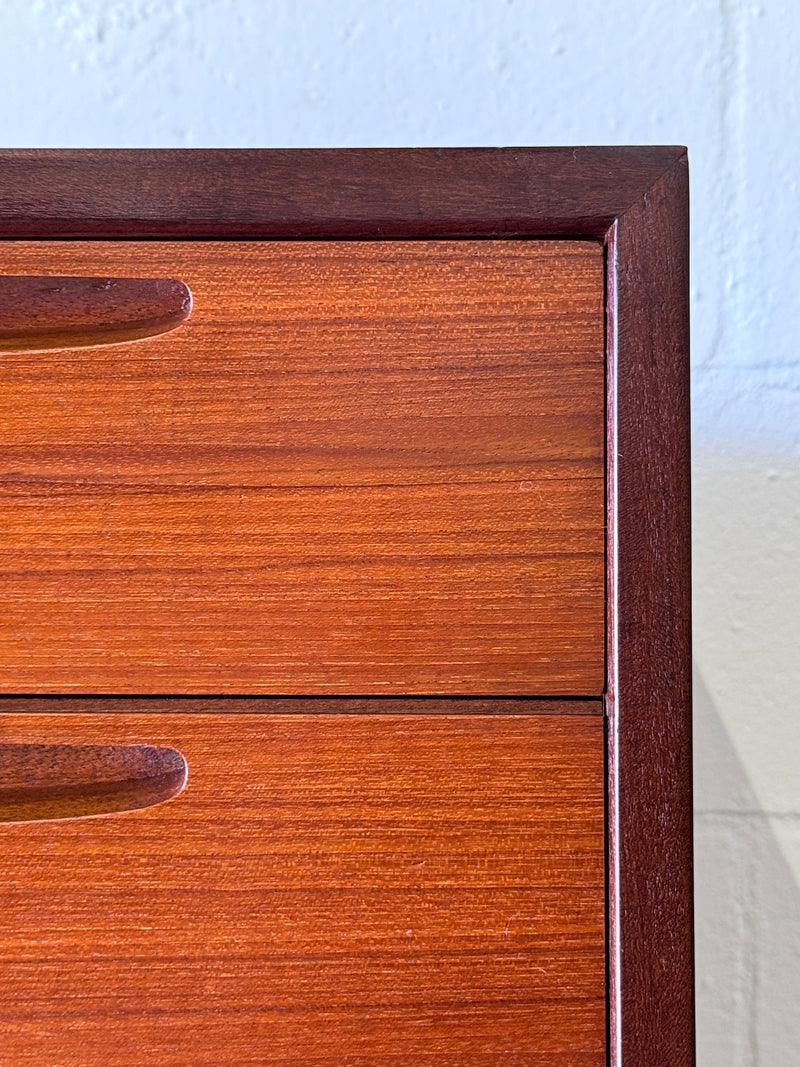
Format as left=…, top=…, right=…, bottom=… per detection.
left=606, top=152, right=694, bottom=1067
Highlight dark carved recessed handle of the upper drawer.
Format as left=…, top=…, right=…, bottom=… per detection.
left=0, top=275, right=192, bottom=351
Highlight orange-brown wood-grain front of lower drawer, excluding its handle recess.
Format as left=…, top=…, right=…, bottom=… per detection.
left=0, top=714, right=606, bottom=1067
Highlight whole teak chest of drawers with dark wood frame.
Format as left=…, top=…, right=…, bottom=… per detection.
left=0, top=148, right=693, bottom=1067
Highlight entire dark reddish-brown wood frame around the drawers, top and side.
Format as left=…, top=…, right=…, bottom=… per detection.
left=0, top=147, right=694, bottom=1067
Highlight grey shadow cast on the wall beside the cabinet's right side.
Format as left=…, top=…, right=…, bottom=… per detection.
left=694, top=673, right=800, bottom=1067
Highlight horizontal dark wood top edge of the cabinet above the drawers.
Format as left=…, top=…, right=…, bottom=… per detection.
left=0, top=147, right=682, bottom=240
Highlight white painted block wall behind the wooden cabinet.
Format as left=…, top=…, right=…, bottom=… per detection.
left=0, top=0, right=800, bottom=1067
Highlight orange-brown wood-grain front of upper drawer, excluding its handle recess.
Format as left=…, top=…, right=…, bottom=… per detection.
left=0, top=241, right=605, bottom=695
